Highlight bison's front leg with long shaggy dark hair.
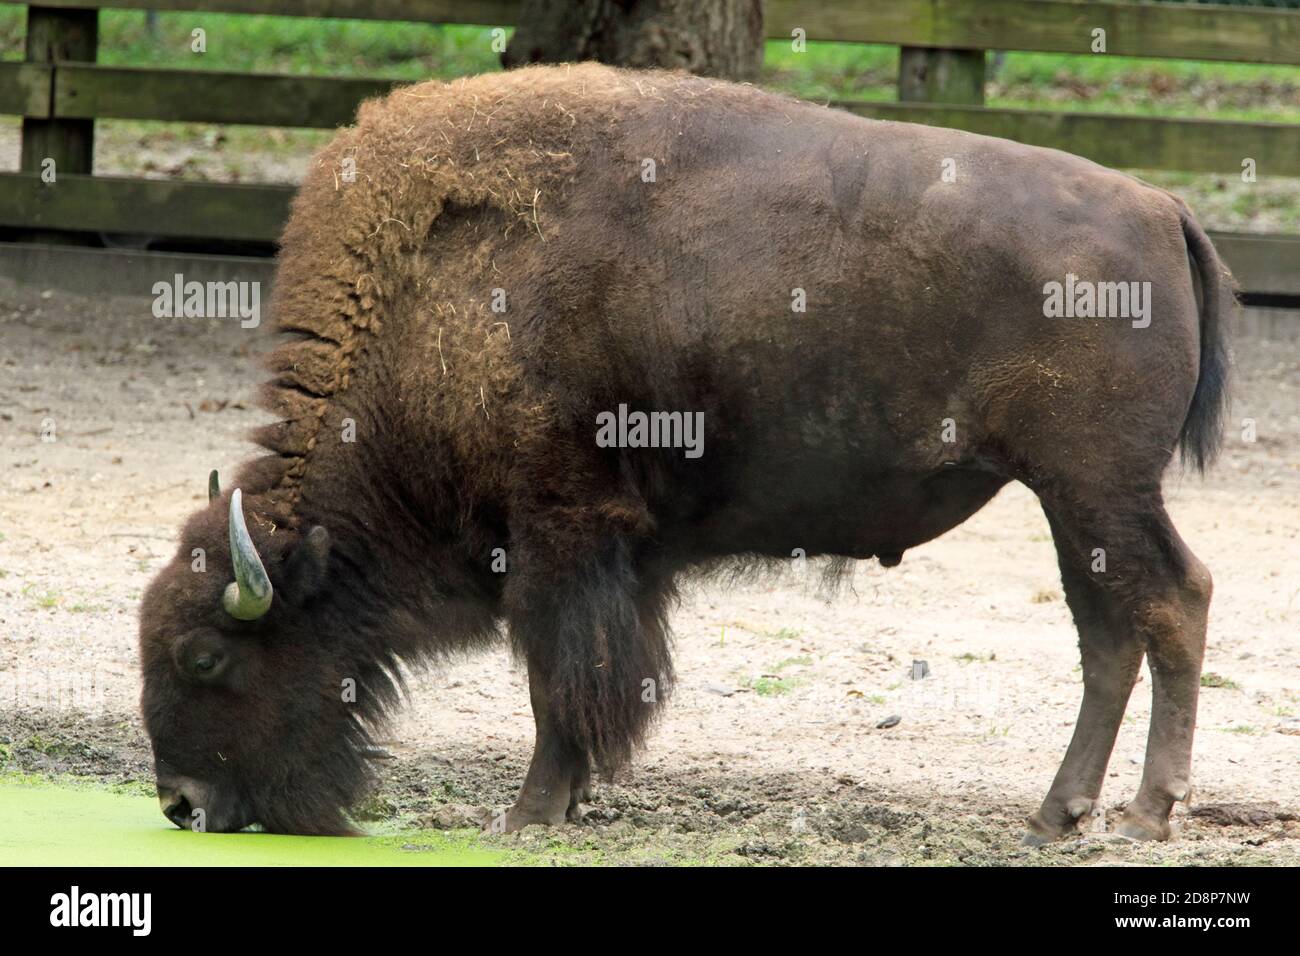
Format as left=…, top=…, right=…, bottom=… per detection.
left=506, top=524, right=671, bottom=830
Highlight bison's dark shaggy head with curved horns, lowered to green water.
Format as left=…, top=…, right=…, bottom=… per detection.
left=140, top=473, right=369, bottom=834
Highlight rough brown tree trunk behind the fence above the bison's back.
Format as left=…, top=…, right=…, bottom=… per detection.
left=501, top=0, right=763, bottom=81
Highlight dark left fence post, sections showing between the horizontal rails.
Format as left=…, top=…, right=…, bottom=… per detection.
left=20, top=7, right=99, bottom=176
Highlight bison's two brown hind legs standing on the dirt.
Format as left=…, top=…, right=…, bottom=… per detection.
left=1026, top=483, right=1210, bottom=843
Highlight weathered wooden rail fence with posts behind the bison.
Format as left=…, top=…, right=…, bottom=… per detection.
left=0, top=0, right=1300, bottom=297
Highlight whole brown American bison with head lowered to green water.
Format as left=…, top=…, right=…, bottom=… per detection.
left=140, top=65, right=1234, bottom=842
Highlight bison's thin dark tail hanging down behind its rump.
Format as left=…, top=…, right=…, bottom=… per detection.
left=1178, top=204, right=1236, bottom=472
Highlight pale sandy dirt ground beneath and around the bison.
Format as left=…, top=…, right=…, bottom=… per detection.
left=0, top=286, right=1300, bottom=865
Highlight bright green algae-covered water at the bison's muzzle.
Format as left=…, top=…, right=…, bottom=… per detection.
left=0, top=778, right=504, bottom=866
